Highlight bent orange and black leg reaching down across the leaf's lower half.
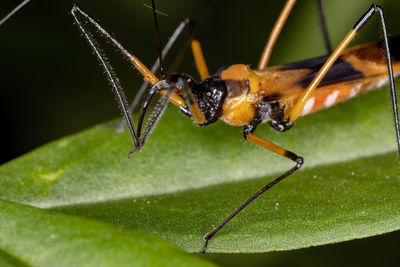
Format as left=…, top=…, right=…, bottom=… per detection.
left=203, top=127, right=303, bottom=253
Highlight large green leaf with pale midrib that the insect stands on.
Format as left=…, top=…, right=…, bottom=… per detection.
left=0, top=88, right=400, bottom=252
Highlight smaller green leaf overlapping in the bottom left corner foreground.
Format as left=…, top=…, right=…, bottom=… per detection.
left=0, top=201, right=216, bottom=266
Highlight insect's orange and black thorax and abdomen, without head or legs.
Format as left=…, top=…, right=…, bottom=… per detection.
left=195, top=38, right=400, bottom=130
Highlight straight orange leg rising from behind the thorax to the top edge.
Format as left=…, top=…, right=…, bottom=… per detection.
left=257, top=0, right=296, bottom=70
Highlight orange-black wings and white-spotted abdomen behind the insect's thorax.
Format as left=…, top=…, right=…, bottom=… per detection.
left=265, top=38, right=400, bottom=118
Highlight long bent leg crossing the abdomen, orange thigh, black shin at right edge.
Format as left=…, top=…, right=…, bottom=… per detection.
left=287, top=4, right=400, bottom=155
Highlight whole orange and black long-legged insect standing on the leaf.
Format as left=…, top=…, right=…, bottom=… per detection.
left=71, top=0, right=400, bottom=252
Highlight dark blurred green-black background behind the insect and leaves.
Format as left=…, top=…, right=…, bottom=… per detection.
left=0, top=0, right=400, bottom=266
